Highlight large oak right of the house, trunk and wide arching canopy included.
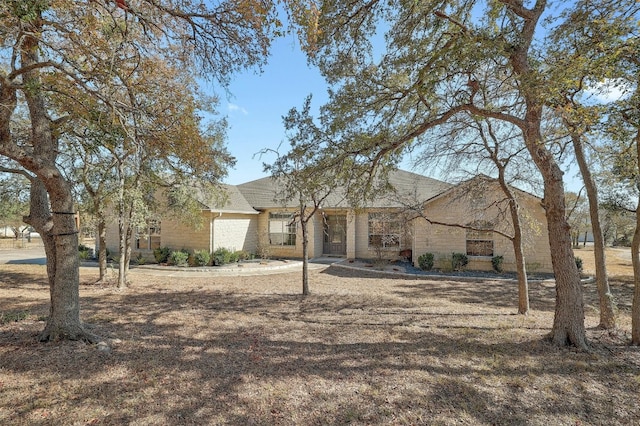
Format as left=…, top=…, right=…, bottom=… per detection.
left=292, top=0, right=638, bottom=348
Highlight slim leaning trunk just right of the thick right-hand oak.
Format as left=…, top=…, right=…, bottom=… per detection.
left=571, top=134, right=616, bottom=330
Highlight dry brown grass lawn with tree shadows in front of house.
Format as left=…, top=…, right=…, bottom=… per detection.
left=0, top=249, right=640, bottom=426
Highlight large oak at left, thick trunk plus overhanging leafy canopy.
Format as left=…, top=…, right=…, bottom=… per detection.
left=0, top=0, right=300, bottom=341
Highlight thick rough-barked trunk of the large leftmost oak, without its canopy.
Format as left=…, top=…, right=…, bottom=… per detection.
left=18, top=24, right=97, bottom=342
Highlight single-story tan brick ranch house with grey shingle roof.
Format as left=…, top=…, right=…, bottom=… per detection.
left=107, top=170, right=552, bottom=272
